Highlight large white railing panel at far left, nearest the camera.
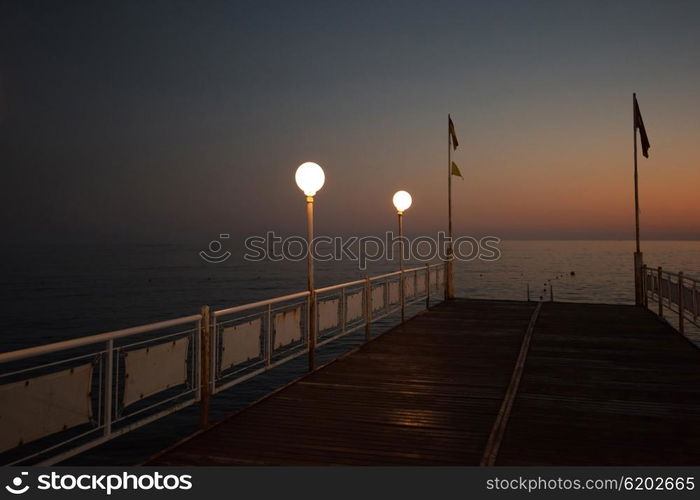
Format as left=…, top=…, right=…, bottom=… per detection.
left=0, top=363, right=93, bottom=451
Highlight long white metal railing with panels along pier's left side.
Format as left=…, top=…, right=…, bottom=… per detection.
left=0, top=263, right=445, bottom=465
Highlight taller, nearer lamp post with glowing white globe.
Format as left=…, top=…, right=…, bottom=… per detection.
left=294, top=161, right=326, bottom=371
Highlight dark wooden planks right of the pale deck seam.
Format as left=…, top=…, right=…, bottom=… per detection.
left=496, top=303, right=700, bottom=465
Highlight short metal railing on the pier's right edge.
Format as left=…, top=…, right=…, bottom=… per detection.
left=642, top=265, right=700, bottom=333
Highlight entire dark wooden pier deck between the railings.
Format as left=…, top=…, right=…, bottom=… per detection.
left=146, top=299, right=700, bottom=466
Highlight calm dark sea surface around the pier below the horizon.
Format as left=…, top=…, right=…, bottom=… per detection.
left=0, top=241, right=700, bottom=464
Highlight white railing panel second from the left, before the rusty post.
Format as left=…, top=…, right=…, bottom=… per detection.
left=124, top=337, right=190, bottom=406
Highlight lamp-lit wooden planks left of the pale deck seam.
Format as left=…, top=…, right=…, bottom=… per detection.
left=149, top=299, right=535, bottom=465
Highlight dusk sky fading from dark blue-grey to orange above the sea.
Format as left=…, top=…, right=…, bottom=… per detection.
left=0, top=0, right=700, bottom=241
